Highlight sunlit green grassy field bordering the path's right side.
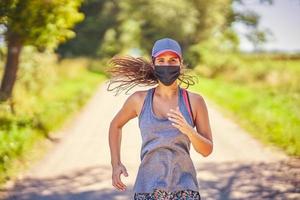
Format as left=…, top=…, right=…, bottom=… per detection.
left=191, top=51, right=300, bottom=156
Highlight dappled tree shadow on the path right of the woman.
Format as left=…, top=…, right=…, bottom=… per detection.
left=196, top=159, right=300, bottom=200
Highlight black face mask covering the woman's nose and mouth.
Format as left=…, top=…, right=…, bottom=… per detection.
left=154, top=65, right=180, bottom=86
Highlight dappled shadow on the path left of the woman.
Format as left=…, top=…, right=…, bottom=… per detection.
left=2, top=166, right=132, bottom=200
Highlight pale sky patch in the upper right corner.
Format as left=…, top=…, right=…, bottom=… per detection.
left=235, top=0, right=300, bottom=52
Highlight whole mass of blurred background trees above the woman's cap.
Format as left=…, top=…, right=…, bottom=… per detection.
left=58, top=0, right=231, bottom=61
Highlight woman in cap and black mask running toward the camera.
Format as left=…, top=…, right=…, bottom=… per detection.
left=109, top=38, right=213, bottom=199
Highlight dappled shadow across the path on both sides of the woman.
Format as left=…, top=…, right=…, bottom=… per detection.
left=2, top=160, right=300, bottom=200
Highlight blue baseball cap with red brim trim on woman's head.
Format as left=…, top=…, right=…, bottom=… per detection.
left=152, top=38, right=182, bottom=59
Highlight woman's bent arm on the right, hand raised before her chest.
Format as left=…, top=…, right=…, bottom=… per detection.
left=169, top=95, right=213, bottom=157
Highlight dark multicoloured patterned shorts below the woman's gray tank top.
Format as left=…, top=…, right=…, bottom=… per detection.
left=134, top=189, right=201, bottom=200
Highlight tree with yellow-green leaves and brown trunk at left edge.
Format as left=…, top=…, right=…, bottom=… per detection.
left=0, top=0, right=84, bottom=101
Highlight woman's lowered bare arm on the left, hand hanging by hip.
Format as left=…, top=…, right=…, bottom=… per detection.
left=109, top=92, right=138, bottom=191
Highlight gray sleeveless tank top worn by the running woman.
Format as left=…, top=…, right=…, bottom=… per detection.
left=133, top=85, right=198, bottom=193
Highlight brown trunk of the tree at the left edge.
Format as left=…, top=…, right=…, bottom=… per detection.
left=0, top=34, right=22, bottom=102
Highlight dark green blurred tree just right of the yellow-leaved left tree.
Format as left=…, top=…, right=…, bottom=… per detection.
left=57, top=0, right=119, bottom=57
